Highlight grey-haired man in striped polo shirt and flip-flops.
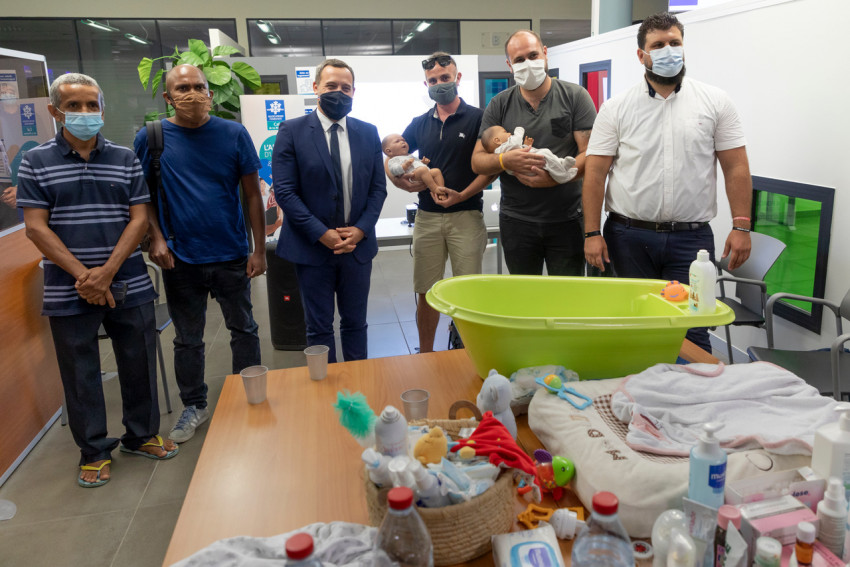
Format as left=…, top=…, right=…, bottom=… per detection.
left=17, top=73, right=177, bottom=487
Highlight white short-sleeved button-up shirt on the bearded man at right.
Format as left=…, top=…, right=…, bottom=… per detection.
left=587, top=78, right=746, bottom=222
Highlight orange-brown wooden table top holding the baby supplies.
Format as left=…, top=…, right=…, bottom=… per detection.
left=164, top=347, right=716, bottom=565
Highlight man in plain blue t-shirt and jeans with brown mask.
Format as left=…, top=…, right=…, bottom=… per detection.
left=134, top=65, right=266, bottom=443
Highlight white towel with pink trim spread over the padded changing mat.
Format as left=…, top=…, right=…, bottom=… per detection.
left=611, top=362, right=838, bottom=456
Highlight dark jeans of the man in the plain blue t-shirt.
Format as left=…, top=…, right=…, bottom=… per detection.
left=162, top=257, right=260, bottom=408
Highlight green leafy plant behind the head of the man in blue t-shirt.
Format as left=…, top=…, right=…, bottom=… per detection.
left=138, top=39, right=260, bottom=122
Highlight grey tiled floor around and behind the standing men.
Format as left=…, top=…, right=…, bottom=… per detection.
left=0, top=245, right=504, bottom=567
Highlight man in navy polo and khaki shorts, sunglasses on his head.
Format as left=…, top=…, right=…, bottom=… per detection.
left=390, top=51, right=492, bottom=352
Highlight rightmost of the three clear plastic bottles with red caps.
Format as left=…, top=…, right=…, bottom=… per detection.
left=571, top=492, right=635, bottom=567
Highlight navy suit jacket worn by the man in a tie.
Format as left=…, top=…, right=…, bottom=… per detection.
left=272, top=110, right=387, bottom=266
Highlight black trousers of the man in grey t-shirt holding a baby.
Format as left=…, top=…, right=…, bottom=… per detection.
left=499, top=215, right=584, bottom=276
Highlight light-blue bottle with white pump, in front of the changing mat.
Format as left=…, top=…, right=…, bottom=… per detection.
left=688, top=423, right=726, bottom=510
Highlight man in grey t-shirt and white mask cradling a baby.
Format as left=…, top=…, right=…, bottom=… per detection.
left=472, top=30, right=596, bottom=276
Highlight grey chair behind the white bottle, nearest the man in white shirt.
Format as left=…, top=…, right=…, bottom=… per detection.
left=717, top=232, right=785, bottom=364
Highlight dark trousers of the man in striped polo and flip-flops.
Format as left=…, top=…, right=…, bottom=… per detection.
left=50, top=301, right=159, bottom=465
